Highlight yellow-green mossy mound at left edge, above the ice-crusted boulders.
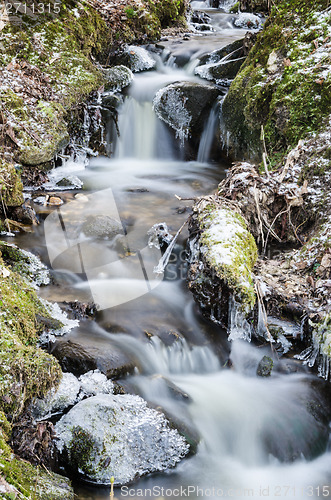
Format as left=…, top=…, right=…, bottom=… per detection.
left=0, top=261, right=61, bottom=418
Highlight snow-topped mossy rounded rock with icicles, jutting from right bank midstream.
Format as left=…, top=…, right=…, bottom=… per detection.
left=188, top=197, right=257, bottom=327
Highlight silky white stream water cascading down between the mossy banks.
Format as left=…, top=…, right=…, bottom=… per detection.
left=6, top=3, right=331, bottom=500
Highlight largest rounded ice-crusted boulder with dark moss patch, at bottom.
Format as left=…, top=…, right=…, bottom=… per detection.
left=56, top=395, right=189, bottom=485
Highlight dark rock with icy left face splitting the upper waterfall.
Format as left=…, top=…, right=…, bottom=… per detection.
left=153, top=82, right=220, bottom=141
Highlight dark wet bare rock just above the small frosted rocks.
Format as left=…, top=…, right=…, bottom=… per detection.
left=51, top=338, right=134, bottom=378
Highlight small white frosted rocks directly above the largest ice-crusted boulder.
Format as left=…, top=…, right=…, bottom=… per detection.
left=32, top=370, right=114, bottom=420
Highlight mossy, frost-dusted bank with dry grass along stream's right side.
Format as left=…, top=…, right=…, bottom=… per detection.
left=190, top=1, right=331, bottom=378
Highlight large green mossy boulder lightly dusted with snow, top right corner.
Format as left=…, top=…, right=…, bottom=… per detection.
left=223, top=0, right=331, bottom=155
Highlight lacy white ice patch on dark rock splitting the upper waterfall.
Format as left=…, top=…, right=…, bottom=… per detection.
left=153, top=85, right=192, bottom=143
